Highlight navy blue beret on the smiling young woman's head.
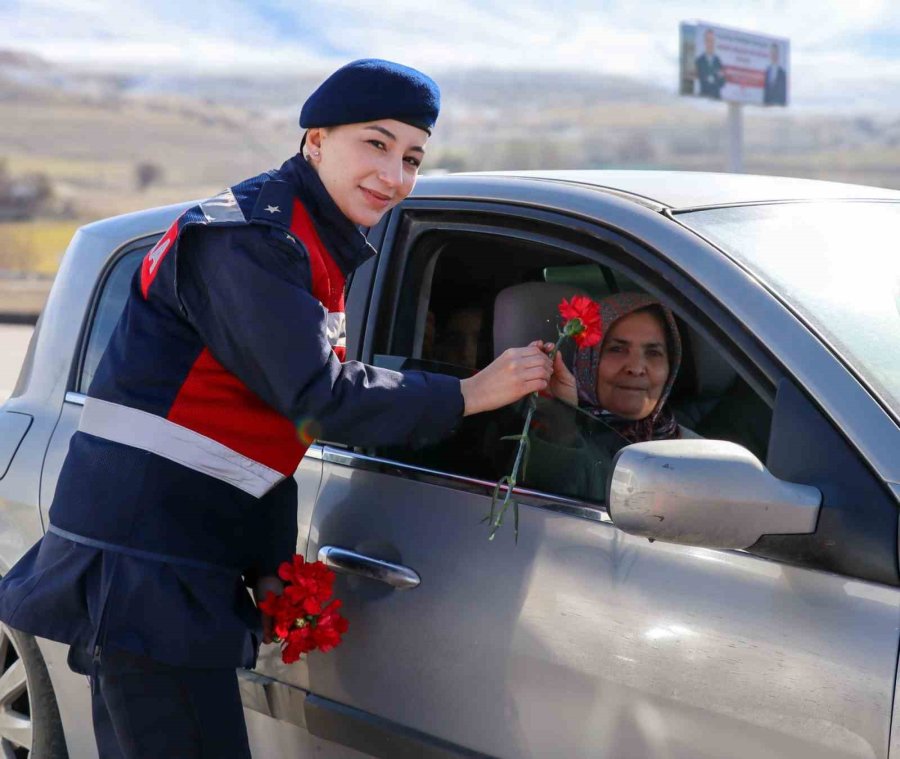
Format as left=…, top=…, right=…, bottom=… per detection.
left=300, top=58, right=441, bottom=133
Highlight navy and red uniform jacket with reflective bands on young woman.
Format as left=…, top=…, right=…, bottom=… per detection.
left=0, top=156, right=463, bottom=667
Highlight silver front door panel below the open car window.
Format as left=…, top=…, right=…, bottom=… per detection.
left=307, top=453, right=900, bottom=757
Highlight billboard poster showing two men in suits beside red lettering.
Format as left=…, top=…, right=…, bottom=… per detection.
left=679, top=21, right=790, bottom=105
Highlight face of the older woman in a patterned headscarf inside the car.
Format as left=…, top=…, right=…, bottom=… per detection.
left=597, top=311, right=669, bottom=419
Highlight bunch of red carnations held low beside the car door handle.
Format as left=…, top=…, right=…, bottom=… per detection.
left=259, top=554, right=350, bottom=664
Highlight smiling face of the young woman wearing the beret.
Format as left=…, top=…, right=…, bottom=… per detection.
left=307, top=119, right=428, bottom=227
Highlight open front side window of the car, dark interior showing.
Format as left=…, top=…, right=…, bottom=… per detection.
left=366, top=233, right=771, bottom=503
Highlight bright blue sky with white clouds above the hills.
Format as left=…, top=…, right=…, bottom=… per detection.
left=0, top=0, right=900, bottom=110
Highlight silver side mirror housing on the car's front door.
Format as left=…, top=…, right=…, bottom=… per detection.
left=606, top=440, right=822, bottom=548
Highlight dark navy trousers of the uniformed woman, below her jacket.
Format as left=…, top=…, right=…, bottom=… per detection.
left=69, top=648, right=250, bottom=759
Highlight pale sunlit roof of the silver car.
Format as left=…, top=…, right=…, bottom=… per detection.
left=454, top=170, right=900, bottom=211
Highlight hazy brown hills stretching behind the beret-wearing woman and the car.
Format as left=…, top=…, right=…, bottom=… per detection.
left=0, top=46, right=900, bottom=226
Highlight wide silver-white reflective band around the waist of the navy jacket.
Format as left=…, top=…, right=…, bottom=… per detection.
left=78, top=397, right=284, bottom=498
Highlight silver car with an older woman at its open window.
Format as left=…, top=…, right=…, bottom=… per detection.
left=0, top=172, right=900, bottom=759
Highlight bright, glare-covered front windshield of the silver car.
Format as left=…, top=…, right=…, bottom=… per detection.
left=679, top=201, right=900, bottom=415
